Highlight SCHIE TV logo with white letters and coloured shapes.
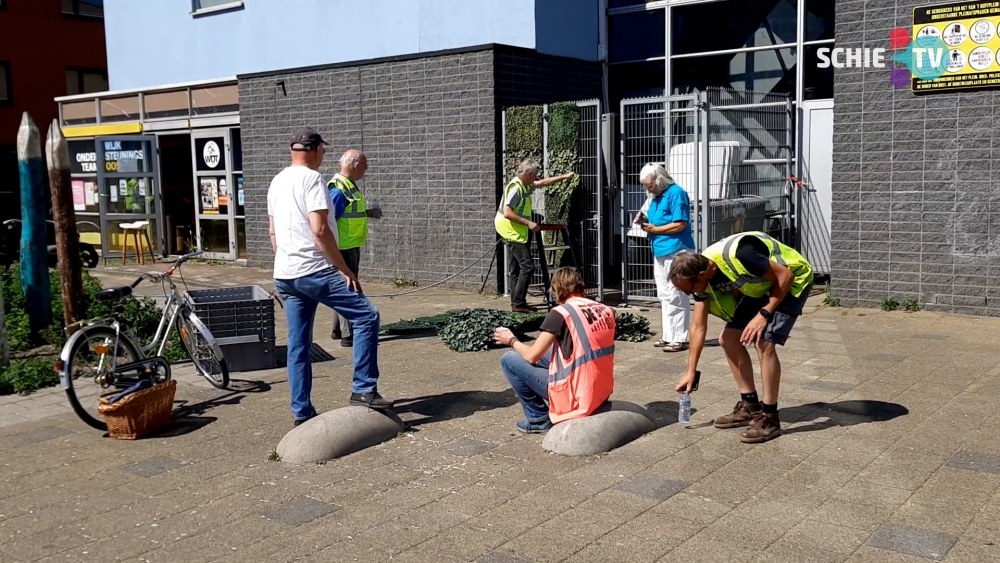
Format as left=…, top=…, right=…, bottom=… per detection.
left=816, top=26, right=944, bottom=88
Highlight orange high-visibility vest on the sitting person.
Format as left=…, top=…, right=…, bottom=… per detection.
left=549, top=297, right=615, bottom=424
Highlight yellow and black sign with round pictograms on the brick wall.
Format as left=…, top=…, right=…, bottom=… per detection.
left=910, top=1, right=1000, bottom=94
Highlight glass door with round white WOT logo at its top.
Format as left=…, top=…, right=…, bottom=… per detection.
left=191, top=129, right=238, bottom=260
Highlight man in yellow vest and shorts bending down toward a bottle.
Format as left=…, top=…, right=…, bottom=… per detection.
left=670, top=232, right=813, bottom=444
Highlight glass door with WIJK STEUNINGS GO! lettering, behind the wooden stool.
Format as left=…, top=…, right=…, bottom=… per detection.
left=97, top=135, right=163, bottom=260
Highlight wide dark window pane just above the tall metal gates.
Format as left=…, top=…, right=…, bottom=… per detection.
left=673, top=48, right=795, bottom=98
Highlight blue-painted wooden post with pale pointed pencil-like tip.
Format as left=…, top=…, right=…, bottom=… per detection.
left=17, top=112, right=52, bottom=339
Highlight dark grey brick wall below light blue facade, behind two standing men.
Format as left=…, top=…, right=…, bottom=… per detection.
left=240, top=45, right=601, bottom=289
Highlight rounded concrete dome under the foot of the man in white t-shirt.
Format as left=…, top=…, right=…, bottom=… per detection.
left=277, top=406, right=406, bottom=463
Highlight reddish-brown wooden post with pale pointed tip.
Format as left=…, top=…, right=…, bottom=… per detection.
left=45, top=119, right=83, bottom=326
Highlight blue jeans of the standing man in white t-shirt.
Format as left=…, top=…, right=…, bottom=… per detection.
left=274, top=268, right=379, bottom=420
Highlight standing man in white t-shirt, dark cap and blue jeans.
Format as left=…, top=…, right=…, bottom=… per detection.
left=267, top=127, right=392, bottom=426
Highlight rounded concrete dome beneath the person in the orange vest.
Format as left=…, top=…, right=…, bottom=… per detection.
left=542, top=401, right=656, bottom=456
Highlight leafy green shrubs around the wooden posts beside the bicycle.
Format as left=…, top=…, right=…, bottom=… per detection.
left=0, top=265, right=188, bottom=395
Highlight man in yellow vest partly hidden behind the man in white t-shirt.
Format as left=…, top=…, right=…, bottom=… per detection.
left=327, top=149, right=379, bottom=348
